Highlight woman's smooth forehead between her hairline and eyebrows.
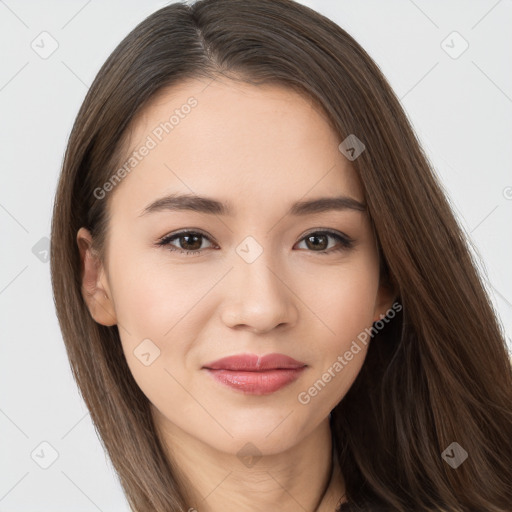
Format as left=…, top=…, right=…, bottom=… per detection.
left=112, top=79, right=363, bottom=217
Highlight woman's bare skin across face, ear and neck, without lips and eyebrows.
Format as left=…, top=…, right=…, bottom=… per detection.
left=77, top=79, right=392, bottom=512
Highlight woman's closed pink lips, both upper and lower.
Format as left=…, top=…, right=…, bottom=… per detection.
left=203, top=354, right=307, bottom=395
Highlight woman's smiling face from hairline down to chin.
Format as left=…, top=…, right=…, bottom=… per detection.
left=79, top=80, right=391, bottom=454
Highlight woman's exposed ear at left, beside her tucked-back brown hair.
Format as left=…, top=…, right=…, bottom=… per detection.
left=76, top=227, right=117, bottom=326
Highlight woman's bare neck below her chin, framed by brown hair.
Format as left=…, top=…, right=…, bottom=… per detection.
left=154, top=411, right=344, bottom=512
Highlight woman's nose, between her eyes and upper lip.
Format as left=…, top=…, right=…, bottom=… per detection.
left=221, top=251, right=298, bottom=334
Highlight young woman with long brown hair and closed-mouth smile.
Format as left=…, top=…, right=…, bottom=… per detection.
left=51, top=0, right=512, bottom=512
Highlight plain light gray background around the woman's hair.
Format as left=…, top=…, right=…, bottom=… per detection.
left=0, top=0, right=512, bottom=512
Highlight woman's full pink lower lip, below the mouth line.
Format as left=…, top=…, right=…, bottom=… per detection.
left=206, top=366, right=306, bottom=395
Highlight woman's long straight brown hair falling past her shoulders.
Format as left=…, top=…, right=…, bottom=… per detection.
left=51, top=0, right=512, bottom=512
